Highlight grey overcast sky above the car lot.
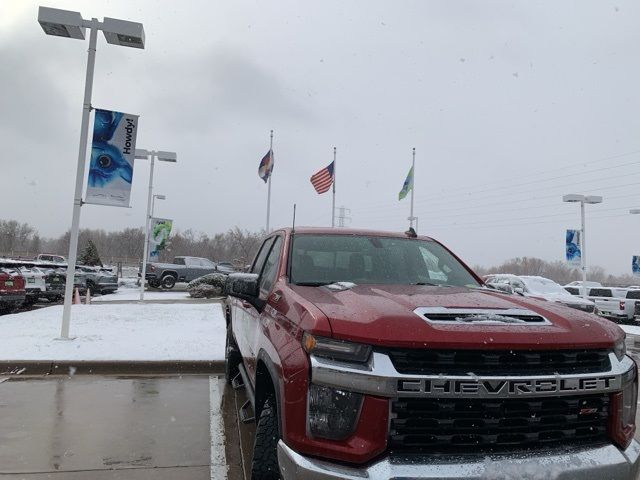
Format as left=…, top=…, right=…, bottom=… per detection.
left=0, top=0, right=640, bottom=273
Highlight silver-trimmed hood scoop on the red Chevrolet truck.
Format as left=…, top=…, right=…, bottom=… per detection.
left=414, top=307, right=551, bottom=326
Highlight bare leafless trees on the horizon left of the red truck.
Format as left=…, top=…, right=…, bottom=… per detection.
left=0, top=220, right=264, bottom=266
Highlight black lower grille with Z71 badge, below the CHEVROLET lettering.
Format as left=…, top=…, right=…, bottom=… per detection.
left=389, top=394, right=609, bottom=453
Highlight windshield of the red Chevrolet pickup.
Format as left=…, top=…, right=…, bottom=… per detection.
left=291, top=234, right=480, bottom=287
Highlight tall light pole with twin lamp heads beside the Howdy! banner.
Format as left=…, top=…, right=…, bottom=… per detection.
left=38, top=7, right=144, bottom=339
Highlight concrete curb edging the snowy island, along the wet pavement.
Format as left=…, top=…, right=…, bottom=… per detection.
left=0, top=360, right=224, bottom=376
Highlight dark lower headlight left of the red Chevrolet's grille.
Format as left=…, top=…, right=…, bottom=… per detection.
left=308, top=384, right=363, bottom=440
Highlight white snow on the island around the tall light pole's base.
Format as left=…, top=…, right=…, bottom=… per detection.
left=0, top=303, right=226, bottom=361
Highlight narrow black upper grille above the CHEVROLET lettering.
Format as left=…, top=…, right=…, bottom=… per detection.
left=385, top=349, right=611, bottom=376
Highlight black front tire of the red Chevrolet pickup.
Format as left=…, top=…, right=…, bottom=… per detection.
left=251, top=397, right=280, bottom=480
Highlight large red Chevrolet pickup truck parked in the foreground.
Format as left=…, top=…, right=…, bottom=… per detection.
left=226, top=228, right=640, bottom=480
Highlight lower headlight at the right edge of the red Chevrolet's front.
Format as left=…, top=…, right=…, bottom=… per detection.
left=609, top=364, right=638, bottom=450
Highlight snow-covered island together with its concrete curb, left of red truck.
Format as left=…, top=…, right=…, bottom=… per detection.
left=0, top=302, right=226, bottom=374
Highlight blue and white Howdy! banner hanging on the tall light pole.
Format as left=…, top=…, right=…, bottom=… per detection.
left=85, top=109, right=138, bottom=207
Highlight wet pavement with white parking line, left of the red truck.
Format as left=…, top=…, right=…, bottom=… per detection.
left=0, top=375, right=253, bottom=480
